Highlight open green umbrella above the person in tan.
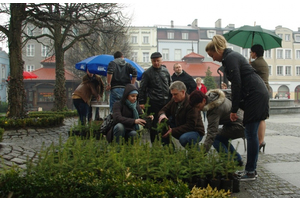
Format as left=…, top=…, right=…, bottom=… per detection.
left=223, top=26, right=282, bottom=50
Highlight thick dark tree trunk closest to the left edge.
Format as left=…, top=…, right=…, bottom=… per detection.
left=8, top=3, right=26, bottom=118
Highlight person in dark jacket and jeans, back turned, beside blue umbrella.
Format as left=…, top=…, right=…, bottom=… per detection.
left=106, top=51, right=137, bottom=112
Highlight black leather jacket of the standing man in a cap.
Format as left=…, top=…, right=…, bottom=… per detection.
left=139, top=65, right=171, bottom=104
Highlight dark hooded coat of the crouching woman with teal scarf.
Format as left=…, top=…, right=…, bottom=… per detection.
left=106, top=84, right=143, bottom=142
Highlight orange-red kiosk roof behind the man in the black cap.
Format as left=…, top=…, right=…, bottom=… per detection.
left=162, top=61, right=220, bottom=78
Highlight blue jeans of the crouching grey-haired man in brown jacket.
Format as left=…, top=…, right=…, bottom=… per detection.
left=161, top=131, right=203, bottom=147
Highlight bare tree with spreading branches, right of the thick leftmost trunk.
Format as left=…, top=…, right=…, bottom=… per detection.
left=26, top=3, right=127, bottom=110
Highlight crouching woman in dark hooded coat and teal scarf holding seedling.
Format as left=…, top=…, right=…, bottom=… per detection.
left=106, top=84, right=153, bottom=143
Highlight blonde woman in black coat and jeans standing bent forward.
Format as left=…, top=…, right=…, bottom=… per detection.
left=205, top=35, right=269, bottom=181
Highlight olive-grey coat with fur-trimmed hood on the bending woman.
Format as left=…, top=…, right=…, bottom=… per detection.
left=203, top=89, right=245, bottom=151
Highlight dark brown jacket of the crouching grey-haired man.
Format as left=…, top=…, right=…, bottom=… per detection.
left=158, top=94, right=205, bottom=139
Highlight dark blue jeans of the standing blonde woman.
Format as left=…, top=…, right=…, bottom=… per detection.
left=245, top=121, right=260, bottom=172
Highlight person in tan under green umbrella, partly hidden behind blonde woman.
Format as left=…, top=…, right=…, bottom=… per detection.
left=250, top=44, right=270, bottom=152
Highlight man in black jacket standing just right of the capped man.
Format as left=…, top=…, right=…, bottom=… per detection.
left=171, top=63, right=197, bottom=94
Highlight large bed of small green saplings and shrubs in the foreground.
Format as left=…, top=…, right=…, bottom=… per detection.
left=0, top=134, right=240, bottom=198
